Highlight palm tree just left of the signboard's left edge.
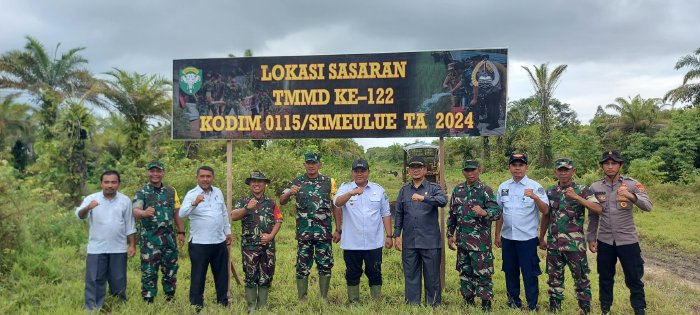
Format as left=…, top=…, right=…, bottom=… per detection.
left=100, top=68, right=172, bottom=158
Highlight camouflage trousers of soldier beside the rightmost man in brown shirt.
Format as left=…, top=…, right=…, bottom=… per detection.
left=547, top=249, right=591, bottom=302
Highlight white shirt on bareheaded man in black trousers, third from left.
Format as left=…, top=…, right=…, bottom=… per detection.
left=179, top=186, right=231, bottom=244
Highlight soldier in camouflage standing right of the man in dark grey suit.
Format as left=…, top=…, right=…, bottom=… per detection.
left=447, top=160, right=501, bottom=311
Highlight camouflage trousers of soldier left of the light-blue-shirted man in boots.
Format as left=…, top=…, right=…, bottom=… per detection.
left=296, top=240, right=333, bottom=279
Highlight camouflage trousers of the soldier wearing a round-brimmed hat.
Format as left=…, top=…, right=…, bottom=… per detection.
left=241, top=244, right=275, bottom=288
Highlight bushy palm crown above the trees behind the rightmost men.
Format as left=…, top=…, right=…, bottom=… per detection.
left=605, top=94, right=665, bottom=135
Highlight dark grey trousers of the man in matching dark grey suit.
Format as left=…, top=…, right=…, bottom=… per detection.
left=401, top=247, right=442, bottom=306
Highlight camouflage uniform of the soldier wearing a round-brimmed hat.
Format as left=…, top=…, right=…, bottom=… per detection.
left=233, top=194, right=282, bottom=288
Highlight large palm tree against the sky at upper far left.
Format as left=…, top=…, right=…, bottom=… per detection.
left=0, top=36, right=98, bottom=139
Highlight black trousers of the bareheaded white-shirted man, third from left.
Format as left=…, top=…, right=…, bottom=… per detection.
left=188, top=242, right=229, bottom=307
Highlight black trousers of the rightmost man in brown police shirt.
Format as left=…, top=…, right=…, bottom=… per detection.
left=598, top=241, right=647, bottom=309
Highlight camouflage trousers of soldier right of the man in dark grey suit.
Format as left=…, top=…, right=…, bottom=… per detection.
left=457, top=248, right=493, bottom=300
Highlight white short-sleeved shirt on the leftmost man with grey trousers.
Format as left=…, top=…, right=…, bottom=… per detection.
left=75, top=192, right=136, bottom=254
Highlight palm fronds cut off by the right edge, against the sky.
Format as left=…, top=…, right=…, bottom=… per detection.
left=664, top=48, right=700, bottom=107
